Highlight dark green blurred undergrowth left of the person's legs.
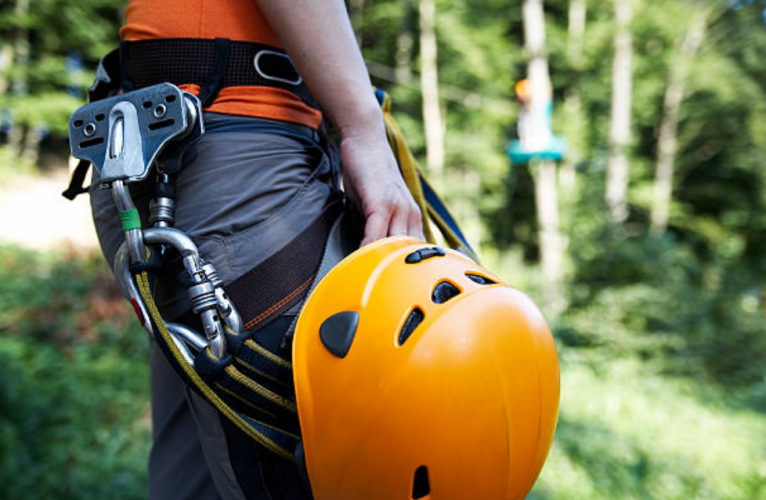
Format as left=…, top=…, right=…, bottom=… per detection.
left=0, top=247, right=151, bottom=500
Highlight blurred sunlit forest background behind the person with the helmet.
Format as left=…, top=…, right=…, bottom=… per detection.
left=0, top=0, right=766, bottom=500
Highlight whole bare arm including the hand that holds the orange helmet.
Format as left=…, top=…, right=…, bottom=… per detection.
left=254, top=0, right=422, bottom=245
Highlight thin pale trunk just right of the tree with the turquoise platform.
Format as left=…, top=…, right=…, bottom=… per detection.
left=559, top=0, right=587, bottom=191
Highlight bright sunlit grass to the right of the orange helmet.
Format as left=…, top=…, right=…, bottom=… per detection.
left=531, top=356, right=766, bottom=500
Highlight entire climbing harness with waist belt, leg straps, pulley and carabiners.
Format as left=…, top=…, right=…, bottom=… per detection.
left=64, top=39, right=486, bottom=468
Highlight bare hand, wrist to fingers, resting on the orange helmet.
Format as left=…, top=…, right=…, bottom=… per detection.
left=340, top=130, right=425, bottom=246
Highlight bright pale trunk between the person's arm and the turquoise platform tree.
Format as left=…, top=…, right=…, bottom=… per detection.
left=420, top=0, right=444, bottom=179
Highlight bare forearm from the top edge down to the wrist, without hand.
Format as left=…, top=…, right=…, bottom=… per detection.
left=254, top=0, right=383, bottom=137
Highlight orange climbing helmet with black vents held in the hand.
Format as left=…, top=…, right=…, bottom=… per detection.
left=293, top=237, right=559, bottom=500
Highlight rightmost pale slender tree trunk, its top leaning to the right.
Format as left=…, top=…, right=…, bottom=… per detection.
left=651, top=7, right=708, bottom=234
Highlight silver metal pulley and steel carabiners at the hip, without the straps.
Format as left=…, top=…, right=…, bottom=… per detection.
left=69, top=83, right=242, bottom=365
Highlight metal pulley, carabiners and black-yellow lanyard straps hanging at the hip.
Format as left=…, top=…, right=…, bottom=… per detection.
left=69, top=83, right=299, bottom=459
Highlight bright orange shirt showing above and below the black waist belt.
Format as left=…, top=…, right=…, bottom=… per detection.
left=120, top=0, right=322, bottom=128
